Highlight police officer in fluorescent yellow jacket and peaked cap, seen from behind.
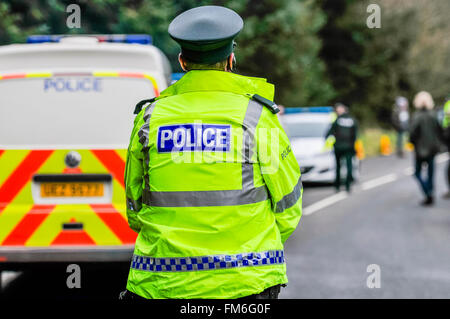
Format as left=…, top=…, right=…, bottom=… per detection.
left=121, top=6, right=303, bottom=299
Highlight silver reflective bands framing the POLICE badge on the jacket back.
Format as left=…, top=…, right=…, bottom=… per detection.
left=142, top=100, right=270, bottom=207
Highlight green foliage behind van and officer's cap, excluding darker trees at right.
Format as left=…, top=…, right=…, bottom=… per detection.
left=0, top=0, right=335, bottom=106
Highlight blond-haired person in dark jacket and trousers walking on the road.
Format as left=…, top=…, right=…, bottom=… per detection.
left=409, top=91, right=442, bottom=206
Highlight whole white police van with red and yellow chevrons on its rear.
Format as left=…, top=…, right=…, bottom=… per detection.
left=0, top=35, right=171, bottom=269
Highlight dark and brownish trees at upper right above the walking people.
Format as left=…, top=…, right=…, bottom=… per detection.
left=320, top=0, right=450, bottom=127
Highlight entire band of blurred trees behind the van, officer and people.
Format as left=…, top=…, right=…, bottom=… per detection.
left=0, top=0, right=450, bottom=128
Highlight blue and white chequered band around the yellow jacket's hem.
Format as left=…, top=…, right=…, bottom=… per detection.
left=131, top=250, right=285, bottom=272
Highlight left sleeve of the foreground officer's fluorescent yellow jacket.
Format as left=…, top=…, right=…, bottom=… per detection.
left=125, top=111, right=144, bottom=232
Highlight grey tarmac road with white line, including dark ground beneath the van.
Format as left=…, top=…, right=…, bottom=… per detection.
left=0, top=154, right=450, bottom=299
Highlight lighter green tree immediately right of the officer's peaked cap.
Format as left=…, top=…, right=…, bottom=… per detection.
left=235, top=0, right=335, bottom=106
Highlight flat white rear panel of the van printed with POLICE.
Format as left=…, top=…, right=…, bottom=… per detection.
left=0, top=76, right=154, bottom=148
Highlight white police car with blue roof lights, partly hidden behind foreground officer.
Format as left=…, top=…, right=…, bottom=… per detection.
left=280, top=106, right=359, bottom=183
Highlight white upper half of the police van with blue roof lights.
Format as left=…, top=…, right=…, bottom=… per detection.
left=0, top=35, right=171, bottom=148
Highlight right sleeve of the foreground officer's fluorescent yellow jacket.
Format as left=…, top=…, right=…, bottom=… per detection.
left=256, top=108, right=303, bottom=243
